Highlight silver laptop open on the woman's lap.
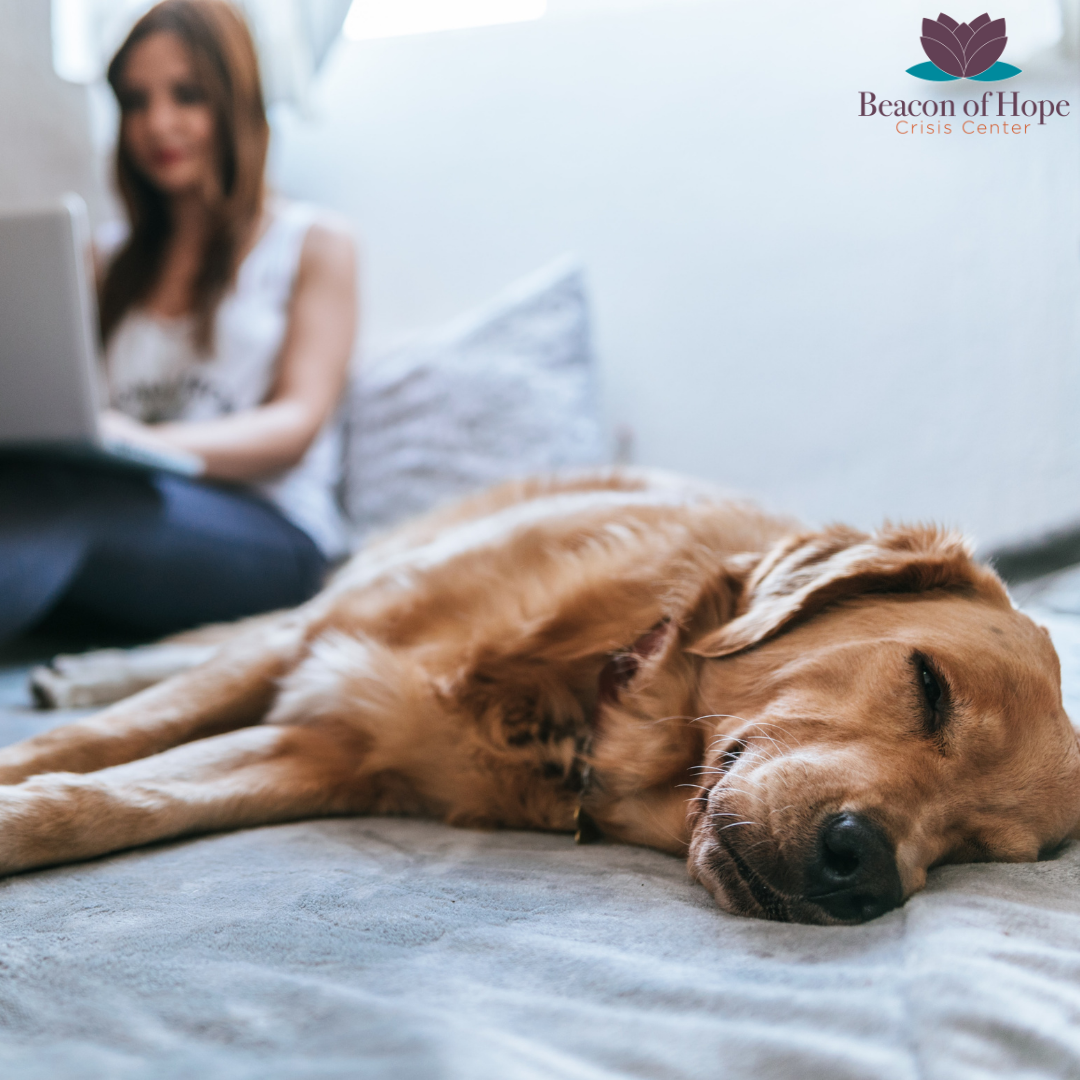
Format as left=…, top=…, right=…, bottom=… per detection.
left=0, top=194, right=202, bottom=476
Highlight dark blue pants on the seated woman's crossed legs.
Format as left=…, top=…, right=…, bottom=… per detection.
left=0, top=461, right=326, bottom=640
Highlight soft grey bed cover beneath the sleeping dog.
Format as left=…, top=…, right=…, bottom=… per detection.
left=0, top=610, right=1080, bottom=1080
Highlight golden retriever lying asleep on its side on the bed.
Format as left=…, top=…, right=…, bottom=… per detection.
left=0, top=472, right=1080, bottom=923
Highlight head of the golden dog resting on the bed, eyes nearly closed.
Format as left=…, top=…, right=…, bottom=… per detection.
left=689, top=528, right=1080, bottom=923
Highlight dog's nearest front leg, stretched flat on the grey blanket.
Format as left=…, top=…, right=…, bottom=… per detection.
left=0, top=725, right=370, bottom=874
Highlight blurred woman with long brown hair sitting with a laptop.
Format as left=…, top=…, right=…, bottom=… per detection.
left=0, top=0, right=355, bottom=638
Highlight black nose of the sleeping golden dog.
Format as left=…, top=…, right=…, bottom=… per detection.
left=804, top=813, right=904, bottom=922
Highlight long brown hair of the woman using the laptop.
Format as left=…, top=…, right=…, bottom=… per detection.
left=100, top=0, right=270, bottom=353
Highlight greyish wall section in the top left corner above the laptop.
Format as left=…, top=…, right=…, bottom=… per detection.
left=0, top=0, right=102, bottom=210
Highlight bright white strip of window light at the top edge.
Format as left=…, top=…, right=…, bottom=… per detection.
left=345, top=0, right=548, bottom=41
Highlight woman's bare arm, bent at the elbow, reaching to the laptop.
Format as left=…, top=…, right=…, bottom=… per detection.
left=104, top=225, right=356, bottom=481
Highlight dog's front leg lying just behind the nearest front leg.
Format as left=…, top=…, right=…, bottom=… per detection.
left=0, top=617, right=305, bottom=784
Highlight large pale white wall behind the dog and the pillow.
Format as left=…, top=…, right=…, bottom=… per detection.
left=274, top=0, right=1080, bottom=544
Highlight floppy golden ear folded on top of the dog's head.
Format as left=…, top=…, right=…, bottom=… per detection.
left=687, top=526, right=1011, bottom=657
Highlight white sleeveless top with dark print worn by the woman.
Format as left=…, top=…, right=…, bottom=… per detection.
left=106, top=200, right=346, bottom=558
